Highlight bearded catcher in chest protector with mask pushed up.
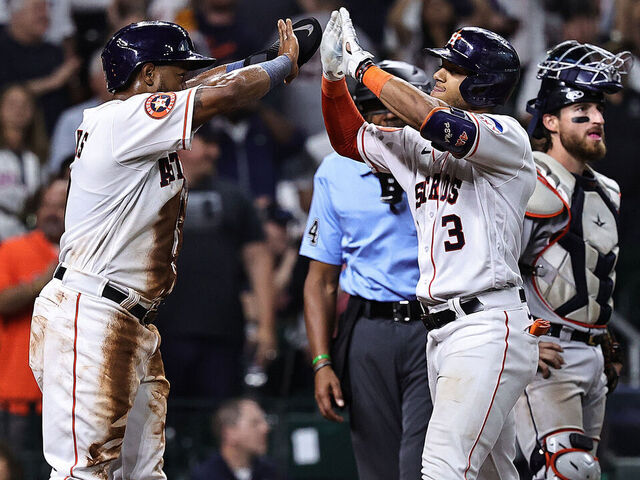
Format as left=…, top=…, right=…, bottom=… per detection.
left=515, top=40, right=630, bottom=480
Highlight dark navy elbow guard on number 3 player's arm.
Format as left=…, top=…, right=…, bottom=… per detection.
left=420, top=107, right=478, bottom=157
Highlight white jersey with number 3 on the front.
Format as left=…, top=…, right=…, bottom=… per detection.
left=358, top=112, right=536, bottom=305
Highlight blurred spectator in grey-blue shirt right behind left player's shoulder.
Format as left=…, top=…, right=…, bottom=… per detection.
left=47, top=52, right=113, bottom=174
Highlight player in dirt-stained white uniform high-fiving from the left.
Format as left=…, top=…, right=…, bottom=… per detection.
left=30, top=20, right=298, bottom=480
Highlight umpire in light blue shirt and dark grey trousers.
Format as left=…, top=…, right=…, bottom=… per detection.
left=300, top=61, right=432, bottom=480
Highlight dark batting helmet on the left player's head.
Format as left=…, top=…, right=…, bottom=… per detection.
left=102, top=22, right=215, bottom=93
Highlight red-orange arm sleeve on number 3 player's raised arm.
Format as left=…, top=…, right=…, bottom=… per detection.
left=322, top=77, right=364, bottom=162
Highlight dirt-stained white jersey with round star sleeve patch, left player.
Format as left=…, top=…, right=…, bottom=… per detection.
left=60, top=87, right=198, bottom=301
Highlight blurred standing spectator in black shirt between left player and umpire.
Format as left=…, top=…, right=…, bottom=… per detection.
left=157, top=126, right=276, bottom=402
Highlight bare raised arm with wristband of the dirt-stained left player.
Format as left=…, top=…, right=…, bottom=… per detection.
left=187, top=19, right=299, bottom=128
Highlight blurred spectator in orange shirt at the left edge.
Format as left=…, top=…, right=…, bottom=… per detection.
left=0, top=179, right=67, bottom=451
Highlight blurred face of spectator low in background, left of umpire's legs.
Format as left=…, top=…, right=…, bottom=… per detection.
left=228, top=401, right=269, bottom=456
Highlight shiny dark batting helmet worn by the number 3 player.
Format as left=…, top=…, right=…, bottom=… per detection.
left=426, top=27, right=520, bottom=107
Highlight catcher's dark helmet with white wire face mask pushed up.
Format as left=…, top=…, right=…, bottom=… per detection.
left=527, top=40, right=632, bottom=138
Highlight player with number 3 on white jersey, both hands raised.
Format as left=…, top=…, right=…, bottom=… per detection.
left=321, top=9, right=538, bottom=480
